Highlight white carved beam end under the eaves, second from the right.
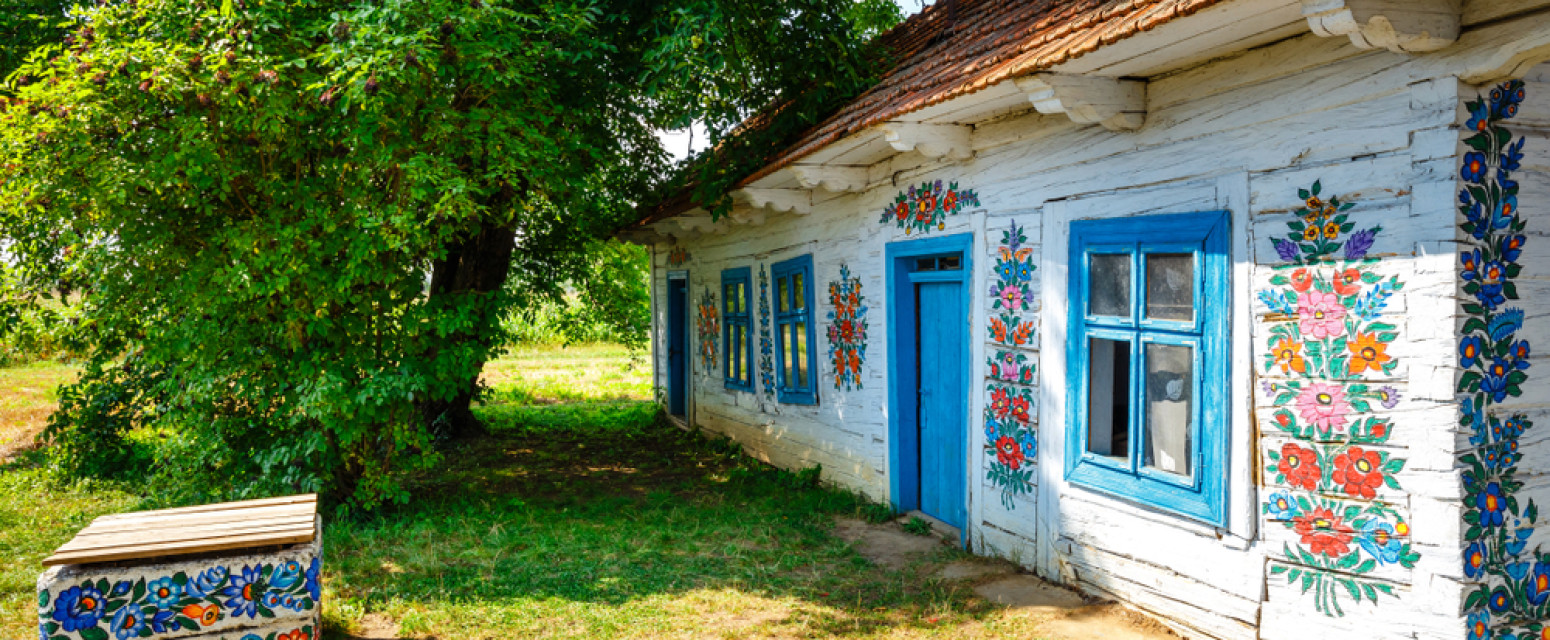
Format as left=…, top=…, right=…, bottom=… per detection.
left=1015, top=73, right=1147, bottom=132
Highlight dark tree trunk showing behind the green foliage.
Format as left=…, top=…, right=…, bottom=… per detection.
left=420, top=215, right=516, bottom=439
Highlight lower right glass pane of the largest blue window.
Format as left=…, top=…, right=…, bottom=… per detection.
left=1145, top=344, right=1195, bottom=477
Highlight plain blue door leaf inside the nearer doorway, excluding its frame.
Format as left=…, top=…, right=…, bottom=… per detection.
left=911, top=274, right=969, bottom=528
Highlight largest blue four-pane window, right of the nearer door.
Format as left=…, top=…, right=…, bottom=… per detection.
left=1066, top=211, right=1232, bottom=525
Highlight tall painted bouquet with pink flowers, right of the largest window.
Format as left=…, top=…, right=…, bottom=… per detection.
left=1259, top=183, right=1420, bottom=615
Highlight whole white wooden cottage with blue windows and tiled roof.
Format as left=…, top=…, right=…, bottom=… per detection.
left=625, top=0, right=1550, bottom=640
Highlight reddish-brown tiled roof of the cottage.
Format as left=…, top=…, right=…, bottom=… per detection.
left=638, top=0, right=1225, bottom=218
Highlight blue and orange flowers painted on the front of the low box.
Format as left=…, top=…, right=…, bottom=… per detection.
left=37, top=558, right=321, bottom=640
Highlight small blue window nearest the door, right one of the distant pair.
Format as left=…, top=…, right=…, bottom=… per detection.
left=770, top=254, right=818, bottom=404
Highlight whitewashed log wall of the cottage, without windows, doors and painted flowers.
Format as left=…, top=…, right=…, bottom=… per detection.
left=654, top=5, right=1550, bottom=640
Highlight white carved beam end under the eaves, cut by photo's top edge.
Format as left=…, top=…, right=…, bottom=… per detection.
left=1302, top=0, right=1463, bottom=53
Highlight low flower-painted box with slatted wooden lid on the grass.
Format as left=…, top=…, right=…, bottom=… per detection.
left=37, top=494, right=322, bottom=640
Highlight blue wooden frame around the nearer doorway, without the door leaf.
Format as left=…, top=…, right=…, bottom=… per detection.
left=884, top=232, right=975, bottom=520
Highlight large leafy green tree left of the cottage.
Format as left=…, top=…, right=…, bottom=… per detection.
left=0, top=0, right=876, bottom=507
